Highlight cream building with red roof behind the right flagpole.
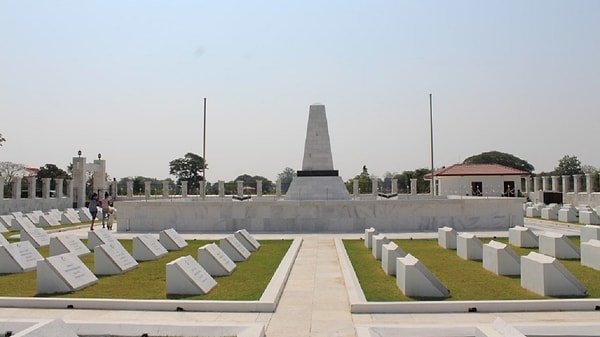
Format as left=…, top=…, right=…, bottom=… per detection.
left=425, top=164, right=529, bottom=197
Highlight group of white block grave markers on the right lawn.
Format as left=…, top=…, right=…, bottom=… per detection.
left=365, top=226, right=600, bottom=297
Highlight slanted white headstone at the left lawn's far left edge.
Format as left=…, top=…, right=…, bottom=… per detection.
left=0, top=241, right=44, bottom=274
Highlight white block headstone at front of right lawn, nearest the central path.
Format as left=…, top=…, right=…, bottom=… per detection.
left=396, top=254, right=450, bottom=297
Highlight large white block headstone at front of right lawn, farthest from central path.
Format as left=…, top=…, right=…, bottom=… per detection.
left=521, top=252, right=587, bottom=296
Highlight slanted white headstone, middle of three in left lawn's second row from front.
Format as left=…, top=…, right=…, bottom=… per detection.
left=94, top=241, right=138, bottom=275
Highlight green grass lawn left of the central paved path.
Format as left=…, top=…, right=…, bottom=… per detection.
left=0, top=236, right=292, bottom=300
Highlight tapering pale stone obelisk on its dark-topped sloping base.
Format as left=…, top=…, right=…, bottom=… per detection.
left=285, top=104, right=350, bottom=200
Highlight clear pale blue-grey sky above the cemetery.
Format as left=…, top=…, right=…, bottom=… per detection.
left=0, top=0, right=600, bottom=182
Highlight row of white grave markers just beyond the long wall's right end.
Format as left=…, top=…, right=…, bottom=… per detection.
left=523, top=202, right=600, bottom=225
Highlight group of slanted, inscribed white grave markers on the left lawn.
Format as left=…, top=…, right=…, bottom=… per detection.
left=0, top=229, right=260, bottom=295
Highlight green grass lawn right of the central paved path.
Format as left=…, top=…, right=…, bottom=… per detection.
left=344, top=237, right=600, bottom=301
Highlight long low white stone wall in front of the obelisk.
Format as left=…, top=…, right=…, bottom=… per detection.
left=116, top=198, right=523, bottom=233
